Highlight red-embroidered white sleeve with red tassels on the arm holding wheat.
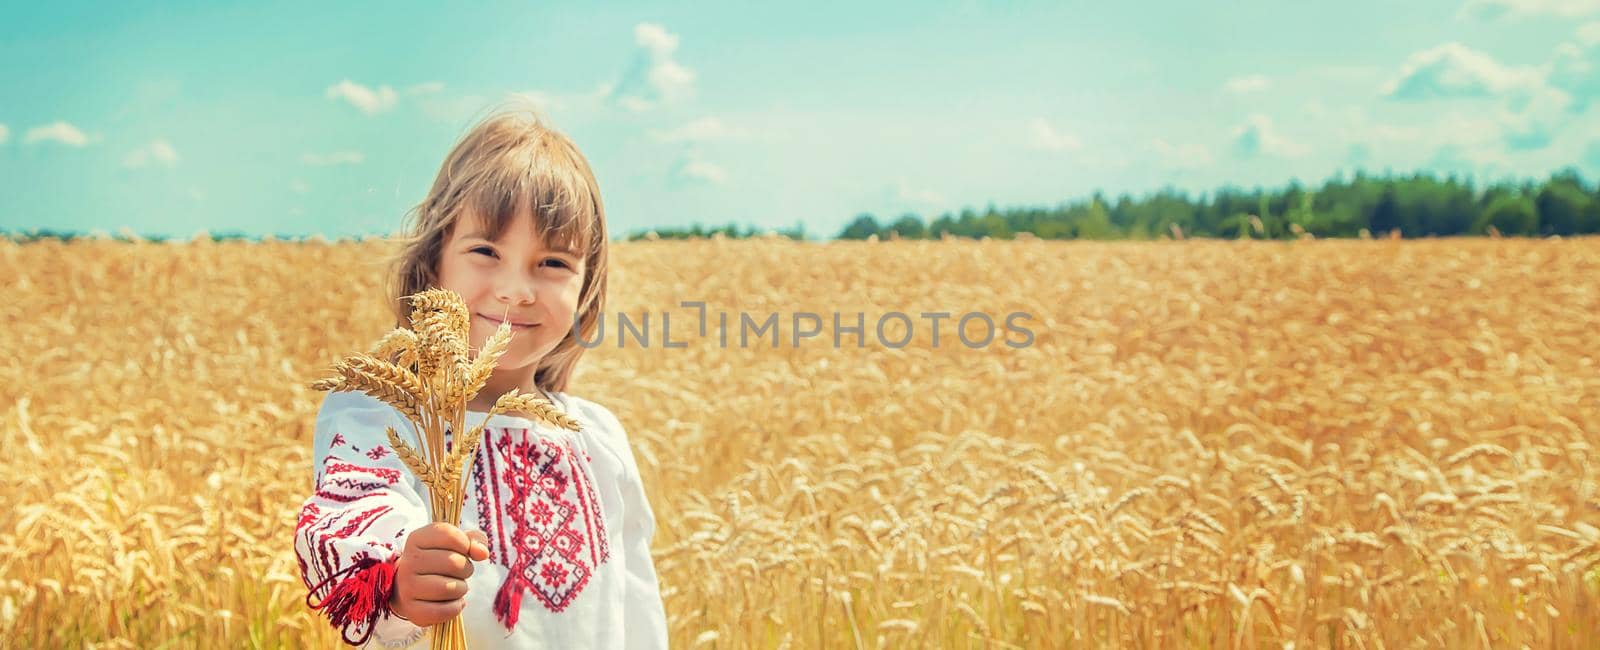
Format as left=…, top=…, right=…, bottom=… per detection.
left=294, top=392, right=429, bottom=647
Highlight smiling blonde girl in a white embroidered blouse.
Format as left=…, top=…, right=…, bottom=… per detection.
left=294, top=110, right=667, bottom=648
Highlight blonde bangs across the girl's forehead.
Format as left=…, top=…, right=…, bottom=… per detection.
left=458, top=138, right=600, bottom=258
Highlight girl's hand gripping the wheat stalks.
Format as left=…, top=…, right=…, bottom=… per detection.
left=389, top=524, right=490, bottom=628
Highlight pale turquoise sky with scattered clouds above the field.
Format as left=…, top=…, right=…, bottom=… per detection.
left=0, top=0, right=1600, bottom=237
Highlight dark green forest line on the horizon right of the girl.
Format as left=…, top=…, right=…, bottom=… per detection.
left=629, top=170, right=1600, bottom=240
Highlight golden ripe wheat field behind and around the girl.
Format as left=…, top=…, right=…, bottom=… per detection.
left=0, top=239, right=1600, bottom=648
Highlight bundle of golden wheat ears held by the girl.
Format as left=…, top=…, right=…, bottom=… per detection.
left=310, top=288, right=579, bottom=650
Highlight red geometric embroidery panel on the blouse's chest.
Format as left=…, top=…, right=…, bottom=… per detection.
left=472, top=429, right=611, bottom=629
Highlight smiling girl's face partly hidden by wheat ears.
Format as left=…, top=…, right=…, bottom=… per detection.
left=438, top=213, right=584, bottom=370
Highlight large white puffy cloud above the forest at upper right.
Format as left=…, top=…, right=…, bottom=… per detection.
left=1384, top=43, right=1544, bottom=99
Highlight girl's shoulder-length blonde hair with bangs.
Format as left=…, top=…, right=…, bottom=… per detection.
left=387, top=107, right=606, bottom=392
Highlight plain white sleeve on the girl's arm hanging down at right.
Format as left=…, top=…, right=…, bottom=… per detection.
left=589, top=402, right=667, bottom=648
